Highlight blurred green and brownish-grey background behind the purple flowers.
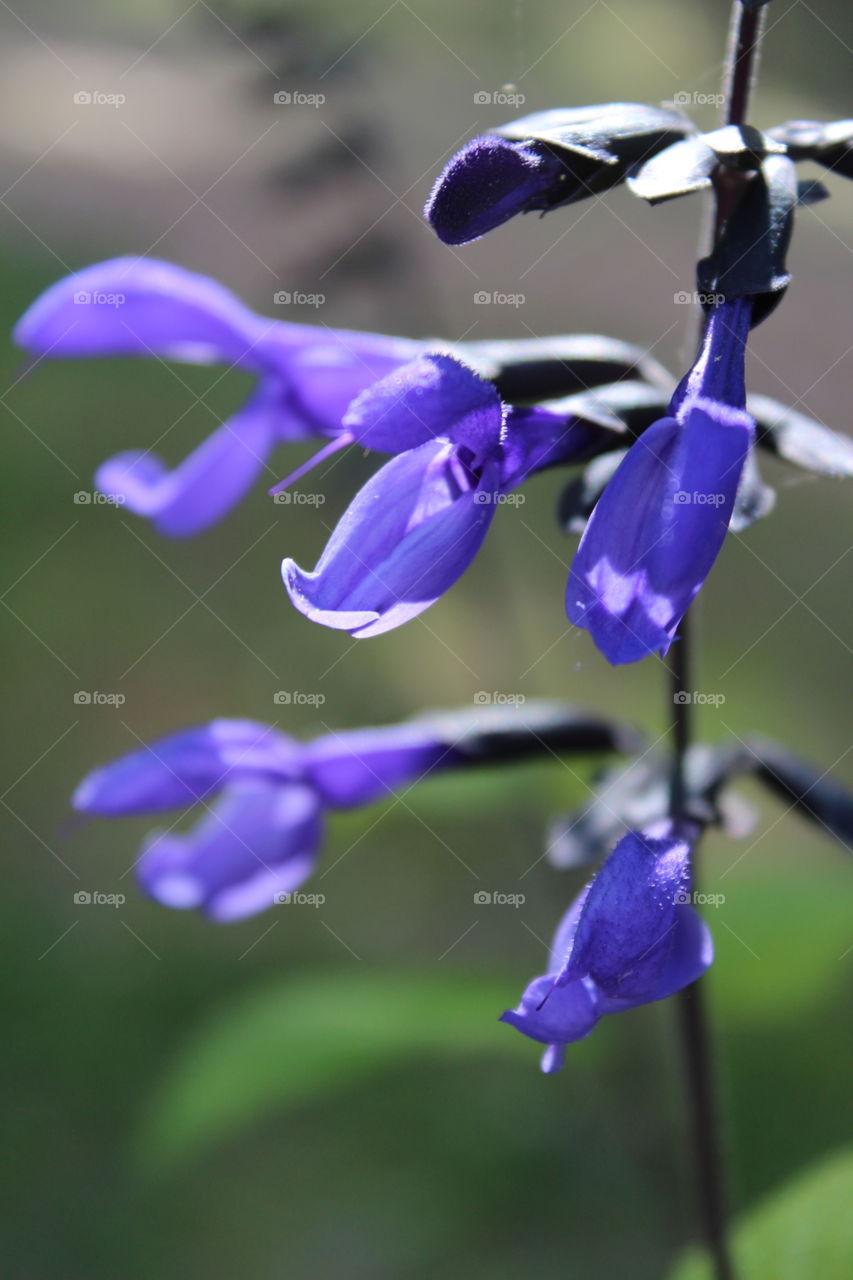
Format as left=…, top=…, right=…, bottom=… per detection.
left=0, top=0, right=853, bottom=1280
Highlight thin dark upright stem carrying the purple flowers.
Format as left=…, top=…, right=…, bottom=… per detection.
left=670, top=0, right=765, bottom=1280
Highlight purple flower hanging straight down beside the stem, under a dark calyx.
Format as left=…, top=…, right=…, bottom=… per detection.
left=566, top=298, right=754, bottom=663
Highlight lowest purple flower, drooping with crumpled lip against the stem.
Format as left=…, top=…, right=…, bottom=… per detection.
left=501, top=820, right=713, bottom=1073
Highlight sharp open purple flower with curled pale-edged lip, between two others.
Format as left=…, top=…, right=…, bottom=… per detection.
left=282, top=355, right=597, bottom=637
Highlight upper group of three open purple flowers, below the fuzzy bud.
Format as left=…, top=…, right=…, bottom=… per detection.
left=15, top=259, right=754, bottom=662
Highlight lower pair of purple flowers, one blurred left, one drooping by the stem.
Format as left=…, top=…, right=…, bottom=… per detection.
left=73, top=705, right=712, bottom=1071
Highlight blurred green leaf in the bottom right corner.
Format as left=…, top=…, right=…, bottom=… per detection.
left=670, top=1148, right=853, bottom=1280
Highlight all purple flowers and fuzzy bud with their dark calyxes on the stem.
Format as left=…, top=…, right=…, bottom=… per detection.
left=15, top=74, right=853, bottom=1071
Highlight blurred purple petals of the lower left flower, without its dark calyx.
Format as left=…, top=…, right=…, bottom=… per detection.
left=72, top=719, right=459, bottom=922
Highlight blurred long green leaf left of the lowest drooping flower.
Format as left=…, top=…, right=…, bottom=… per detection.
left=137, top=970, right=525, bottom=1169
